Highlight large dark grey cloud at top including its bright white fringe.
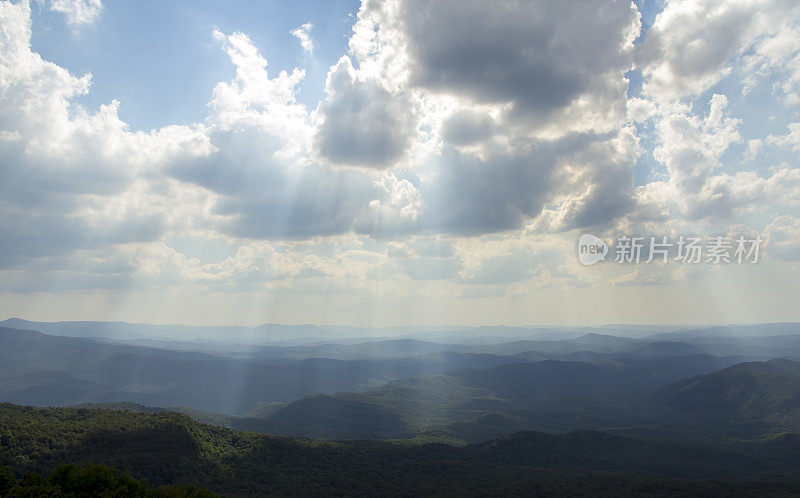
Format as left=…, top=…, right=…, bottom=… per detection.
left=351, top=0, right=639, bottom=134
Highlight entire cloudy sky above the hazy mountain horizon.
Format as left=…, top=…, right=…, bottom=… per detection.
left=0, top=0, right=800, bottom=326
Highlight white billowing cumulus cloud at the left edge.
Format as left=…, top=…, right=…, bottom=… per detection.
left=0, top=2, right=208, bottom=264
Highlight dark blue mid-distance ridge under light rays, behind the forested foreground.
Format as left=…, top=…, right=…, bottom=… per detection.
left=267, top=355, right=738, bottom=442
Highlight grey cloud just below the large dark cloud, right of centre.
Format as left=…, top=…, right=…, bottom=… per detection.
left=421, top=130, right=632, bottom=235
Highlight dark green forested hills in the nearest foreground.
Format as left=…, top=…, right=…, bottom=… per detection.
left=0, top=404, right=800, bottom=496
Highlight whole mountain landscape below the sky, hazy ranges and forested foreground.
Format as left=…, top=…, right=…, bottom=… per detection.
left=0, top=320, right=800, bottom=495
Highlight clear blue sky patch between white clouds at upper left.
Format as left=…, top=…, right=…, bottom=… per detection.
left=31, top=0, right=359, bottom=130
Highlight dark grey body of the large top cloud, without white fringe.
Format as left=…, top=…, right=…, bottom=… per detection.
left=401, top=0, right=638, bottom=114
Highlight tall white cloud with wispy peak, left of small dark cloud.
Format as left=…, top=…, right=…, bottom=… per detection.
left=168, top=31, right=403, bottom=239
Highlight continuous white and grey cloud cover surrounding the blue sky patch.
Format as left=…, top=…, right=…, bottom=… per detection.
left=0, top=0, right=800, bottom=316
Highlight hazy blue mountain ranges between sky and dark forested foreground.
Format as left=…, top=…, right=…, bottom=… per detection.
left=0, top=322, right=800, bottom=443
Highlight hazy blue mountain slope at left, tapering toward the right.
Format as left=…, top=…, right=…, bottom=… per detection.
left=0, top=328, right=532, bottom=415
